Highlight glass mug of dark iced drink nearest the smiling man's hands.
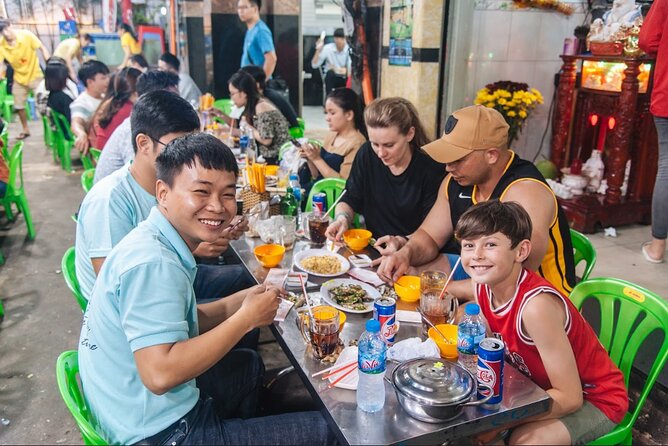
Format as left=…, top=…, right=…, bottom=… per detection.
left=297, top=305, right=340, bottom=359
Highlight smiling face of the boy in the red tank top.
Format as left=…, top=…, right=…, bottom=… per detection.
left=461, top=232, right=531, bottom=286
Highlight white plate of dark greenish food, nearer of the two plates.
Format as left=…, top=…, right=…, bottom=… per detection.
left=320, top=279, right=380, bottom=313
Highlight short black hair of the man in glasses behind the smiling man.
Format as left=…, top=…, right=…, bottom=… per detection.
left=130, top=89, right=199, bottom=153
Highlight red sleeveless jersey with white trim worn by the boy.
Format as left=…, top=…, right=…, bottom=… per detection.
left=476, top=269, right=628, bottom=423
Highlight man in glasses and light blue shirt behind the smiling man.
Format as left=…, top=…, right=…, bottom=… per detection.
left=75, top=91, right=199, bottom=299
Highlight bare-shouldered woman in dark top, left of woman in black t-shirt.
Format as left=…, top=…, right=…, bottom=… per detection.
left=299, top=88, right=366, bottom=196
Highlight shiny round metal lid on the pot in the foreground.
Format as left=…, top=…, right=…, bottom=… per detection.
left=393, top=358, right=475, bottom=406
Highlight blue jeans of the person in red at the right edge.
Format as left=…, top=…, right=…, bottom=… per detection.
left=652, top=116, right=668, bottom=240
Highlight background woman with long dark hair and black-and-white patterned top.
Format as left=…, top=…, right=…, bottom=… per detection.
left=228, top=70, right=290, bottom=164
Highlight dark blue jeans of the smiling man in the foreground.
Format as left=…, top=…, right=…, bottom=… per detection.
left=138, top=349, right=336, bottom=445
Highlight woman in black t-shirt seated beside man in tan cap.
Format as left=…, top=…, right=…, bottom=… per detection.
left=327, top=98, right=445, bottom=242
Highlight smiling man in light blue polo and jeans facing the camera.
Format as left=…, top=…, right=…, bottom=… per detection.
left=79, top=133, right=335, bottom=445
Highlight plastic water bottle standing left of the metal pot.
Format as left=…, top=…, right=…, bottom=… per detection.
left=357, top=319, right=387, bottom=412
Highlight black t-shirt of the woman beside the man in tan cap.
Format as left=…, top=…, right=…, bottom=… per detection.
left=341, top=142, right=445, bottom=237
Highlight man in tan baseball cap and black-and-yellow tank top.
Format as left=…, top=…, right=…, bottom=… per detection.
left=378, top=105, right=575, bottom=298
